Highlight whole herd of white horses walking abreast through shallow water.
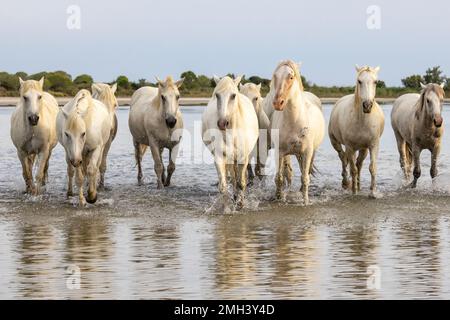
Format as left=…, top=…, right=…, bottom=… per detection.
left=11, top=60, right=444, bottom=208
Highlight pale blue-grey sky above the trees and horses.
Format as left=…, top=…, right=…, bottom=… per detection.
left=0, top=0, right=450, bottom=86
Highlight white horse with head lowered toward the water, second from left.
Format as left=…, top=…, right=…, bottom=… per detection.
left=56, top=90, right=111, bottom=206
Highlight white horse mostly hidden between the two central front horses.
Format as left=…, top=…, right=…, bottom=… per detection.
left=239, top=83, right=270, bottom=180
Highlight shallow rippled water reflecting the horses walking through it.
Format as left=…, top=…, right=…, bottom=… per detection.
left=0, top=105, right=450, bottom=299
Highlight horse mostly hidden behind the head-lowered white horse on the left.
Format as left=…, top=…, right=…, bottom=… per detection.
left=92, top=83, right=118, bottom=189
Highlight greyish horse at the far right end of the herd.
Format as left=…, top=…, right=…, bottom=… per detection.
left=391, top=84, right=445, bottom=188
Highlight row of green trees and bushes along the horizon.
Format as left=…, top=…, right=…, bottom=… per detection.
left=0, top=66, right=450, bottom=98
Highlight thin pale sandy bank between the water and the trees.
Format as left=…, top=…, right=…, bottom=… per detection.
left=0, top=97, right=450, bottom=107
